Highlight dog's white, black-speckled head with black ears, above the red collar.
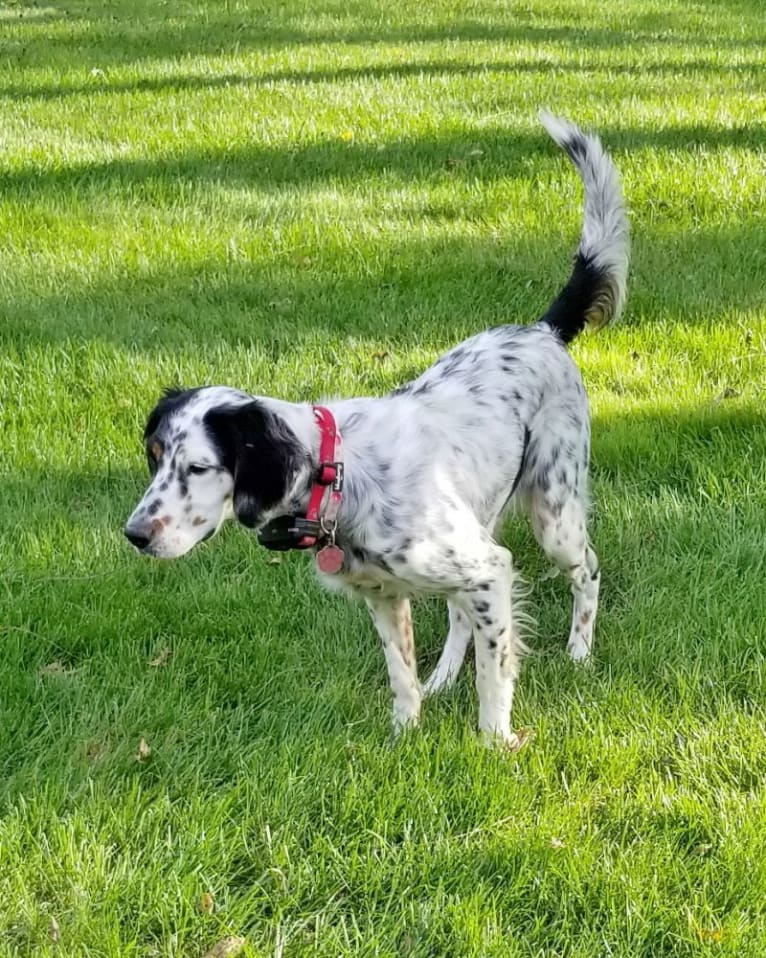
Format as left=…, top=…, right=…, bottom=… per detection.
left=125, top=386, right=308, bottom=559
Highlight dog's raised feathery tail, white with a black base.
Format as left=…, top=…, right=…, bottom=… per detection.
left=540, top=113, right=630, bottom=343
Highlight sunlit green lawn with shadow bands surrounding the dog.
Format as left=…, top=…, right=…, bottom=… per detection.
left=0, top=0, right=766, bottom=958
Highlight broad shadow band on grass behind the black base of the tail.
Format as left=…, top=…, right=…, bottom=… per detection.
left=0, top=219, right=766, bottom=358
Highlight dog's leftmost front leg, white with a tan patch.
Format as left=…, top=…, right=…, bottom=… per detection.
left=367, top=596, right=421, bottom=734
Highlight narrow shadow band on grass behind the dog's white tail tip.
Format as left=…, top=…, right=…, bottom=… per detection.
left=0, top=123, right=766, bottom=200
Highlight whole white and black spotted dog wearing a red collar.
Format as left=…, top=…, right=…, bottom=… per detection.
left=125, top=114, right=629, bottom=746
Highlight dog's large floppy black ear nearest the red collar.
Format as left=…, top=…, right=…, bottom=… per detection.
left=205, top=400, right=306, bottom=528
